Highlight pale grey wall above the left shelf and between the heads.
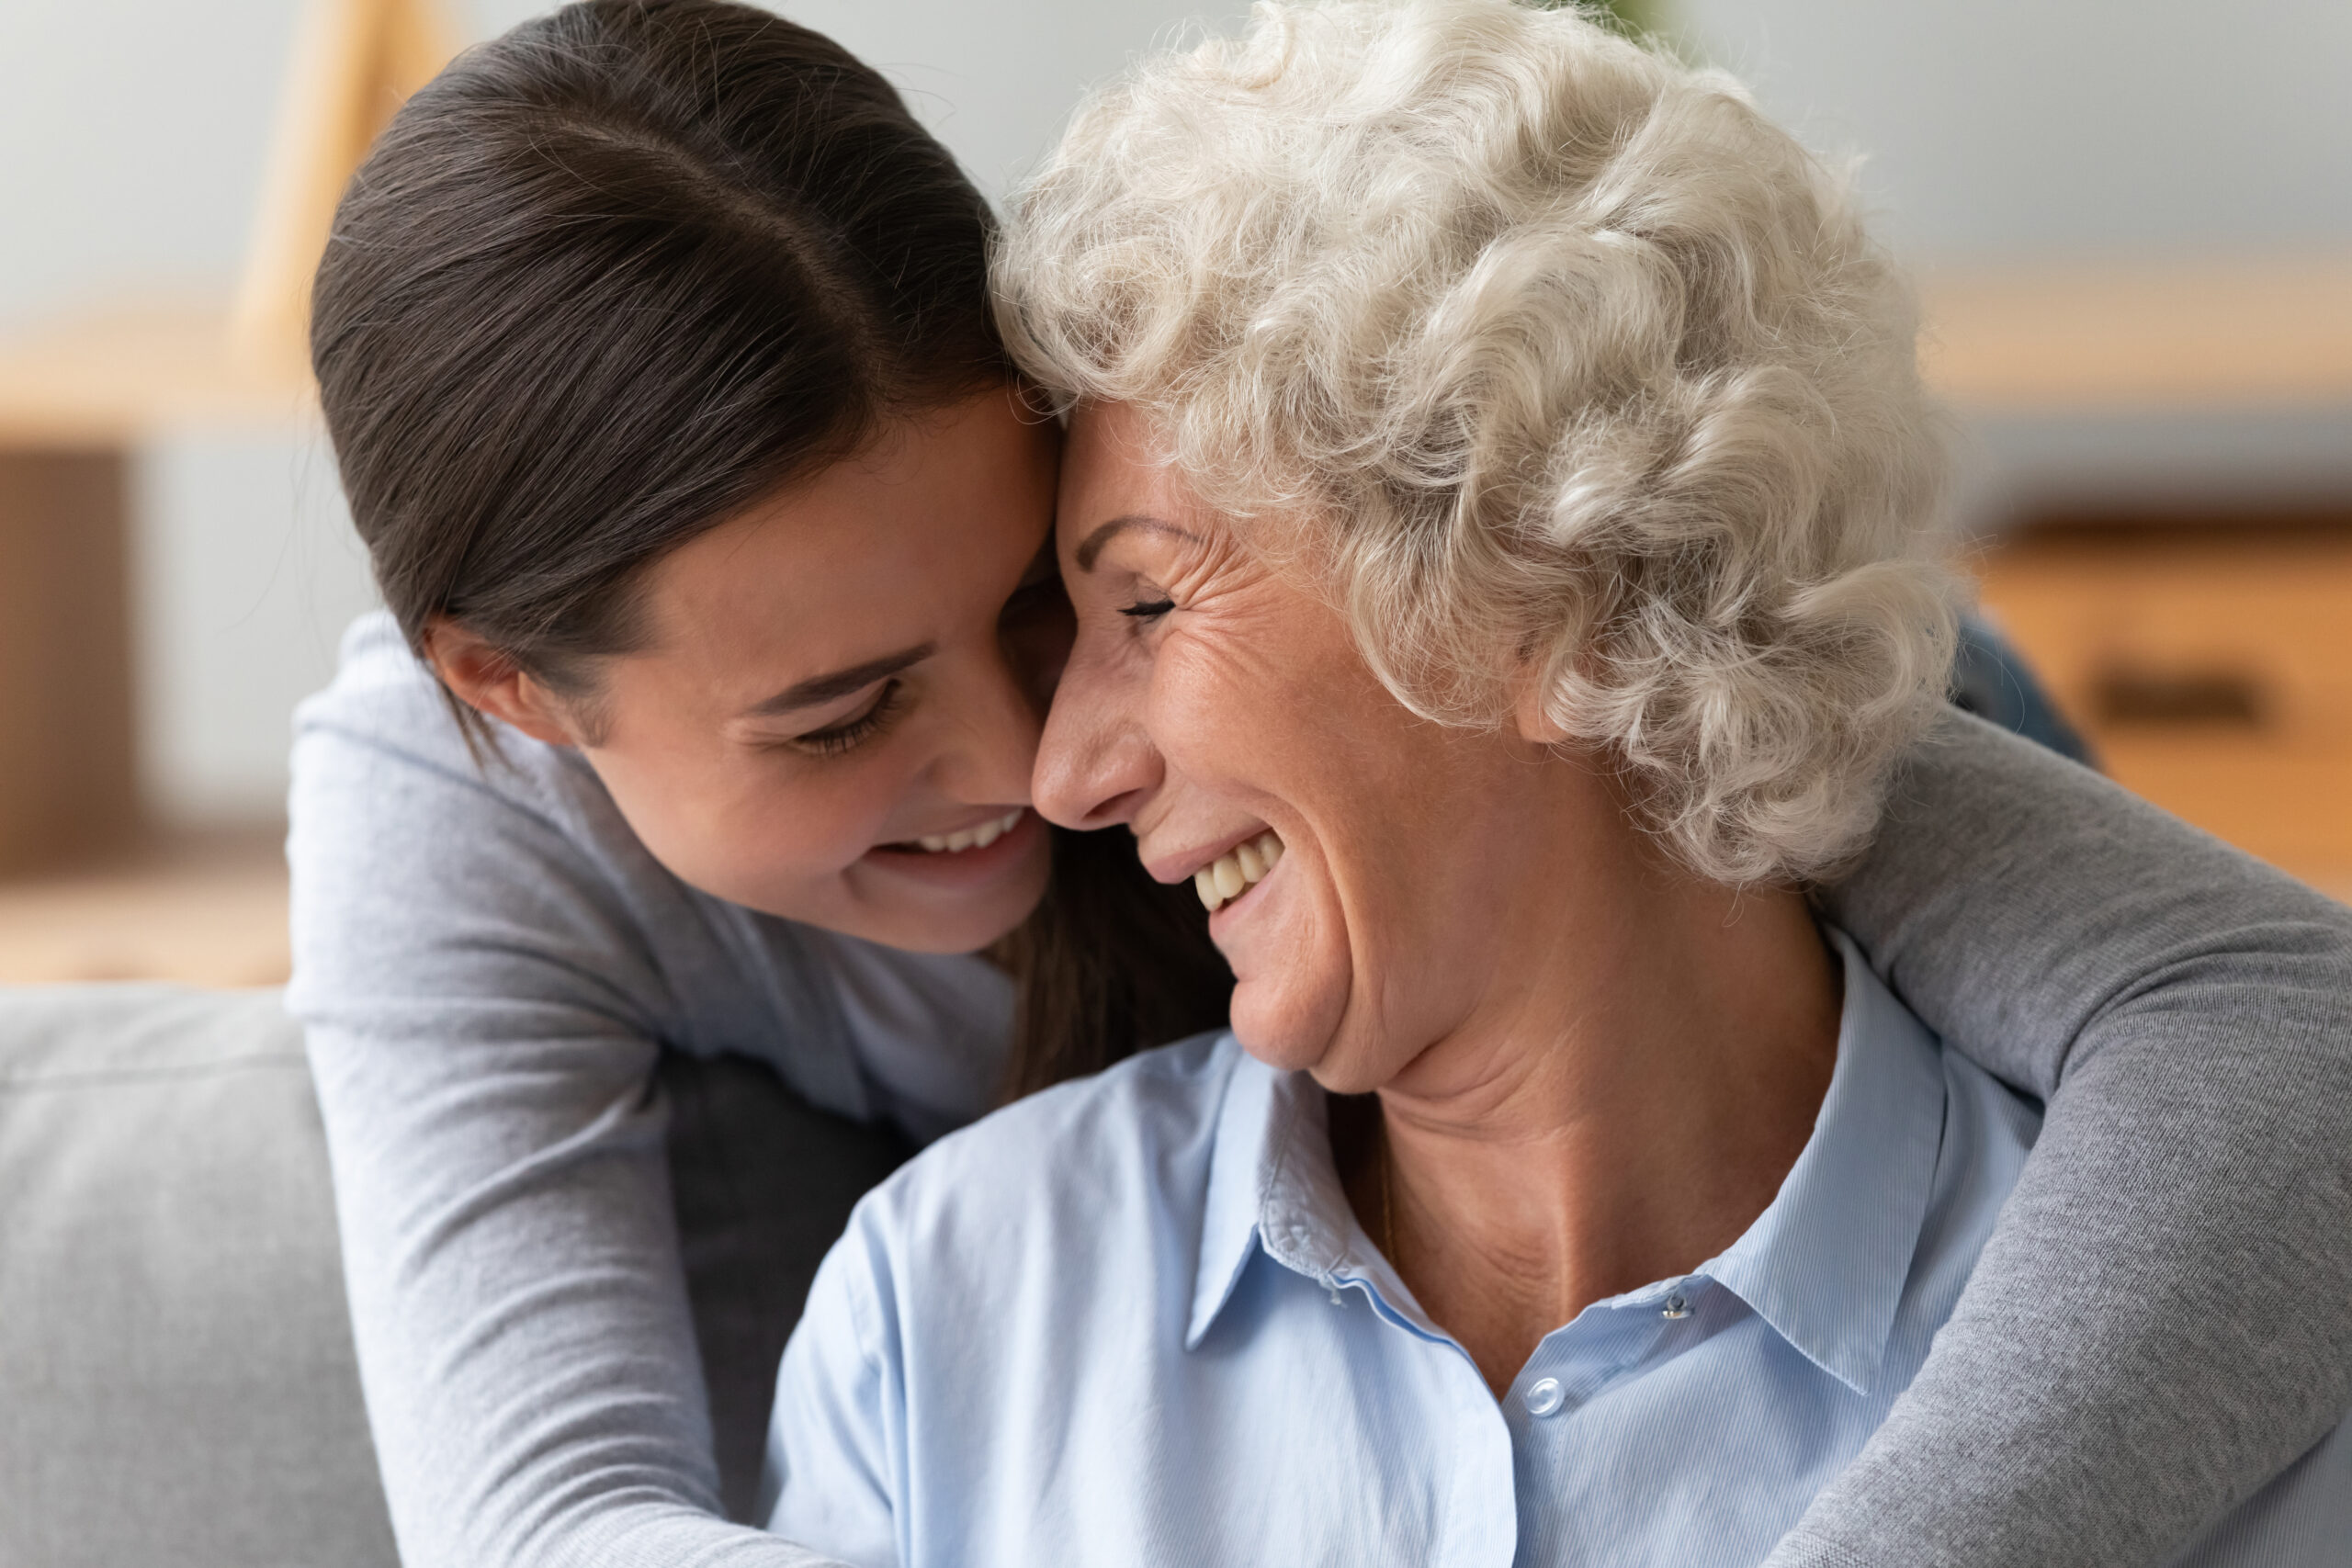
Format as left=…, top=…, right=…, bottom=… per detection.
left=0, top=0, right=1247, bottom=341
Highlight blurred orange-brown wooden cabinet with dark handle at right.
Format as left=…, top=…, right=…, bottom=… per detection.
left=1983, top=513, right=2352, bottom=896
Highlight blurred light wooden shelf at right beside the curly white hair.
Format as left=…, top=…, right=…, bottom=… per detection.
left=1919, top=254, right=2352, bottom=412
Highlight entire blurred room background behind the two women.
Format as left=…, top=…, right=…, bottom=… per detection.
left=0, top=0, right=2352, bottom=985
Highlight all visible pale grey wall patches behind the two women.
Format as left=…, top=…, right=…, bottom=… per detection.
left=0, top=0, right=2352, bottom=818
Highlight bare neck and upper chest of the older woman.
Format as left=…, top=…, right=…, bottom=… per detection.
left=1348, top=861, right=1839, bottom=1394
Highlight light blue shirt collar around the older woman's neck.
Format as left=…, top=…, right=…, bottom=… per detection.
left=1185, top=931, right=1945, bottom=1392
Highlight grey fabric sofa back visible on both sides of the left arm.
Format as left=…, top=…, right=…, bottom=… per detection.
left=0, top=985, right=906, bottom=1568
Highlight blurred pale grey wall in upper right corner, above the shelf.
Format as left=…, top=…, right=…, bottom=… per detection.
left=1672, top=0, right=2352, bottom=261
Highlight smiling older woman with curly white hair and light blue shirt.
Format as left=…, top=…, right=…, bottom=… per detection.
left=772, top=0, right=2352, bottom=1565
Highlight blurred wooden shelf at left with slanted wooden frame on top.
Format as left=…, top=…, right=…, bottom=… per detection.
left=0, top=0, right=458, bottom=879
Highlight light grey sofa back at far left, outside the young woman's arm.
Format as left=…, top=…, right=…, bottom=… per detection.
left=0, top=985, right=398, bottom=1568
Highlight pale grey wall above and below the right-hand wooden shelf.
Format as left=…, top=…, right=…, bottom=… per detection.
left=1672, top=0, right=2352, bottom=529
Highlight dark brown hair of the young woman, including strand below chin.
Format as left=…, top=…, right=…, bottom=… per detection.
left=311, top=0, right=1232, bottom=1090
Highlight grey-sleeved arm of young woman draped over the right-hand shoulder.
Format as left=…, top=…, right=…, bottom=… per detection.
left=1769, top=715, right=2352, bottom=1568
